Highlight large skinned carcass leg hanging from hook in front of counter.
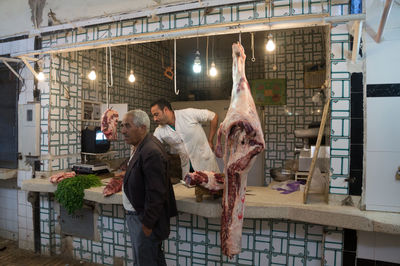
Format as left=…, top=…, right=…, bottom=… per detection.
left=215, top=43, right=265, bottom=258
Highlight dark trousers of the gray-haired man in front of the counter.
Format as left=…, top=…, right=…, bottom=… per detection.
left=126, top=212, right=167, bottom=266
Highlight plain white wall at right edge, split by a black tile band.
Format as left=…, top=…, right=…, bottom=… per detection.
left=364, top=0, right=400, bottom=212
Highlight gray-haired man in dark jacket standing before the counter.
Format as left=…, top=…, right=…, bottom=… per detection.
left=121, top=110, right=177, bottom=266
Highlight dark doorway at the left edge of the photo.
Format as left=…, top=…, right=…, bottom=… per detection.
left=0, top=64, right=18, bottom=169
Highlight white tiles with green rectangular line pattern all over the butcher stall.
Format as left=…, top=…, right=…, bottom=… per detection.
left=36, top=0, right=350, bottom=265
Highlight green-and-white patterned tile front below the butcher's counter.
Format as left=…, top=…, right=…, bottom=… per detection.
left=40, top=193, right=343, bottom=266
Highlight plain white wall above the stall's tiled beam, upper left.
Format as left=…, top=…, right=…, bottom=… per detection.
left=0, top=0, right=187, bottom=38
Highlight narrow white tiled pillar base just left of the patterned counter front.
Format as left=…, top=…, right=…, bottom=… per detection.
left=18, top=170, right=34, bottom=250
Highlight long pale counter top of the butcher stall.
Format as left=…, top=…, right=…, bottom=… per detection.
left=22, top=178, right=400, bottom=234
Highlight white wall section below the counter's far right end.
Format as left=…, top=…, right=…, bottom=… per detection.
left=357, top=231, right=400, bottom=263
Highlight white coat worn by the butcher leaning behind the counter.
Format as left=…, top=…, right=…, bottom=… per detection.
left=153, top=108, right=220, bottom=177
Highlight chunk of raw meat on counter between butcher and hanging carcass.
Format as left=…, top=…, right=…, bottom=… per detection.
left=185, top=171, right=224, bottom=191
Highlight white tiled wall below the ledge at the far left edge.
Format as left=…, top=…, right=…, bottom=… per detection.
left=0, top=188, right=18, bottom=240
